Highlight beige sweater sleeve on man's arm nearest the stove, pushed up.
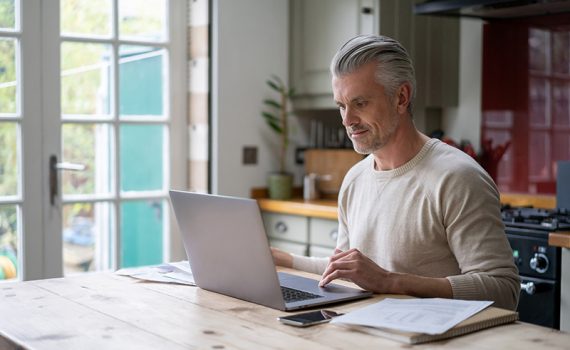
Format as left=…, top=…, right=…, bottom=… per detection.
left=440, top=166, right=520, bottom=310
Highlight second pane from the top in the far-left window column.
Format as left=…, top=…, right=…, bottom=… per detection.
left=0, top=38, right=17, bottom=113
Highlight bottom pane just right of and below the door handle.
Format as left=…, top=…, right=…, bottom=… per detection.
left=63, top=203, right=114, bottom=275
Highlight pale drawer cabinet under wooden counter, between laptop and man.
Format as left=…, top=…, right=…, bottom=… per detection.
left=262, top=212, right=338, bottom=257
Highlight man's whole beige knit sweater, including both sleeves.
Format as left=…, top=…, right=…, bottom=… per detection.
left=293, top=139, right=520, bottom=309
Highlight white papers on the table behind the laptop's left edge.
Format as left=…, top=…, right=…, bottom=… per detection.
left=115, top=260, right=196, bottom=286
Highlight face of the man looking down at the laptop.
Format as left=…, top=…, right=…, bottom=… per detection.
left=332, top=62, right=400, bottom=154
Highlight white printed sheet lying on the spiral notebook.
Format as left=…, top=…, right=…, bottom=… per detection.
left=332, top=298, right=493, bottom=334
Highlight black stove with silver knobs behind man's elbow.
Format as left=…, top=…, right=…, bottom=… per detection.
left=501, top=206, right=560, bottom=329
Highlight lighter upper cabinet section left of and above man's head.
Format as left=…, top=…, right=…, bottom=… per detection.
left=290, top=0, right=379, bottom=110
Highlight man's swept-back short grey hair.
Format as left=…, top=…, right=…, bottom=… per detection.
left=330, top=34, right=416, bottom=116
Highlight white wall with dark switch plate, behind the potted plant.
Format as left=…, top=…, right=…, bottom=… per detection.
left=211, top=0, right=300, bottom=197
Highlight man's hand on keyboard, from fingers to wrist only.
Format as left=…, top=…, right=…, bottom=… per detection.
left=319, top=248, right=390, bottom=293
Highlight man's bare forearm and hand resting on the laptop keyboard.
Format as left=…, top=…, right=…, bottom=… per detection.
left=319, top=248, right=453, bottom=298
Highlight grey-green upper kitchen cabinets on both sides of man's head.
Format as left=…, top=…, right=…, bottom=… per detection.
left=290, top=0, right=460, bottom=110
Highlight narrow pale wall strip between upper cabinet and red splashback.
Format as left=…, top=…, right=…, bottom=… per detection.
left=442, top=18, right=483, bottom=150
